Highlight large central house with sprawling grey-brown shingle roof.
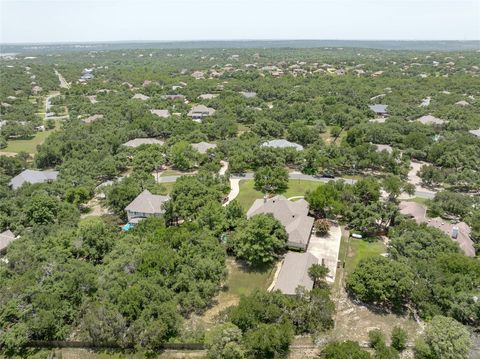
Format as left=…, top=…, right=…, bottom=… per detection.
left=247, top=196, right=314, bottom=250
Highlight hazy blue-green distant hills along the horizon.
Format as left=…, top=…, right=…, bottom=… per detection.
left=0, top=40, right=480, bottom=54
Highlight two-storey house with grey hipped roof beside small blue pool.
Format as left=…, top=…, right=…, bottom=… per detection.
left=125, top=190, right=170, bottom=224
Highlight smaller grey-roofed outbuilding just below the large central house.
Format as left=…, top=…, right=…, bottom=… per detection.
left=273, top=252, right=318, bottom=295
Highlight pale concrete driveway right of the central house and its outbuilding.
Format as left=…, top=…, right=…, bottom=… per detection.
left=307, top=225, right=342, bottom=283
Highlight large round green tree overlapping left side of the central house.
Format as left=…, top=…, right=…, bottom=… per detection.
left=232, top=214, right=288, bottom=266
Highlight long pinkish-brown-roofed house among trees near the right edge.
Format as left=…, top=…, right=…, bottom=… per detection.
left=399, top=201, right=475, bottom=257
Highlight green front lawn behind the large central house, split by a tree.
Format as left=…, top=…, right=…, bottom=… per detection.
left=236, top=179, right=320, bottom=210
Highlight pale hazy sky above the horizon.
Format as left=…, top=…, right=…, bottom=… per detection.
left=0, top=0, right=480, bottom=43
